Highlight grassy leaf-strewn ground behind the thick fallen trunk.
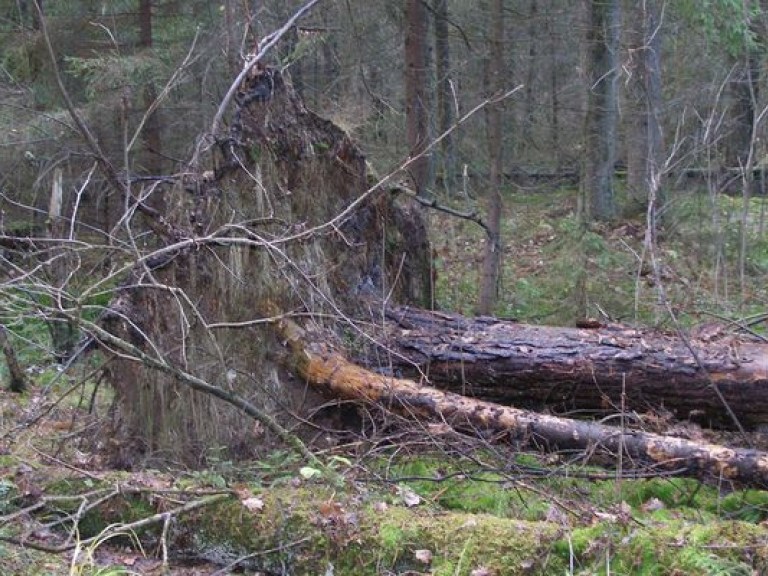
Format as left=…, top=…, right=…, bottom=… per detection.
left=431, top=189, right=768, bottom=328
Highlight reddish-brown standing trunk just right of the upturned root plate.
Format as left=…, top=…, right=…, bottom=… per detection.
left=405, top=0, right=430, bottom=196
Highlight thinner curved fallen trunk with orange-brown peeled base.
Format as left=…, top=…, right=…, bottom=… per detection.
left=275, top=318, right=768, bottom=486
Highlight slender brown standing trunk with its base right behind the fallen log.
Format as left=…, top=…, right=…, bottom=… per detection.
left=477, top=0, right=505, bottom=314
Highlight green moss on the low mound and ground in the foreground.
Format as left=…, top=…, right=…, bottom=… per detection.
left=158, top=464, right=768, bottom=576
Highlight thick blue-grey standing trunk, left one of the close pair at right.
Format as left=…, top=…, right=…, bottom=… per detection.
left=582, top=0, right=621, bottom=221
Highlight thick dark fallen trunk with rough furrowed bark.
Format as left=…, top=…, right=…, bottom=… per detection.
left=380, top=308, right=768, bottom=428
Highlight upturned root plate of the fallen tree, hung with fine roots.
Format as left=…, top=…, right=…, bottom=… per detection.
left=103, top=63, right=431, bottom=465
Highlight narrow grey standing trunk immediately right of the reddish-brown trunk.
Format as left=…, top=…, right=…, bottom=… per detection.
left=432, top=0, right=456, bottom=195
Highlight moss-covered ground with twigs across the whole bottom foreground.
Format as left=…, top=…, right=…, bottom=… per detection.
left=0, top=451, right=768, bottom=576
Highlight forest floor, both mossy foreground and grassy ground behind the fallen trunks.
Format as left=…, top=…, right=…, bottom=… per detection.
left=0, top=191, right=768, bottom=576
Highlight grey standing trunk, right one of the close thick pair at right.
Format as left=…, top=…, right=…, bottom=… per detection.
left=626, top=0, right=663, bottom=216
